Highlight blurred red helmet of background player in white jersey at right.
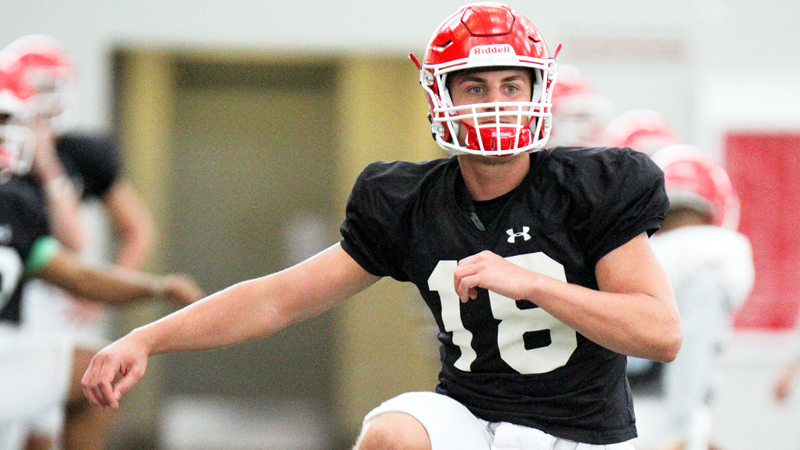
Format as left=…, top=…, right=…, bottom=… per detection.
left=652, top=144, right=739, bottom=230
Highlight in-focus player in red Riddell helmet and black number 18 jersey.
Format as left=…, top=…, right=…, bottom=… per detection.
left=83, top=2, right=682, bottom=450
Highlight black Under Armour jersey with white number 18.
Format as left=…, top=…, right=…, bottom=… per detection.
left=341, top=148, right=668, bottom=444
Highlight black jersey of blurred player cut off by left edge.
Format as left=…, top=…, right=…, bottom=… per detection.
left=0, top=179, right=50, bottom=324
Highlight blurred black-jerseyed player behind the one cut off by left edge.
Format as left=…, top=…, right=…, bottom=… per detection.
left=6, top=35, right=154, bottom=449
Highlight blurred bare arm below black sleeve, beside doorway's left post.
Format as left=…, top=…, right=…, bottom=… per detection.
left=103, top=179, right=155, bottom=269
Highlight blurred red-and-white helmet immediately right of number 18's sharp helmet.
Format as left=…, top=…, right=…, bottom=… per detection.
left=548, top=65, right=614, bottom=147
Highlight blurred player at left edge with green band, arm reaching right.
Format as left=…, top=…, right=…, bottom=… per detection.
left=0, top=54, right=203, bottom=450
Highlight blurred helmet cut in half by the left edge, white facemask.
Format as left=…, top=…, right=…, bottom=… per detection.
left=0, top=52, right=34, bottom=183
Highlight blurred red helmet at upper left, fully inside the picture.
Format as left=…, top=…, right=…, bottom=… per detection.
left=6, top=34, right=77, bottom=129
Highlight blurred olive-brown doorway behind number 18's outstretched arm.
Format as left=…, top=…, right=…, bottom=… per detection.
left=111, top=52, right=338, bottom=450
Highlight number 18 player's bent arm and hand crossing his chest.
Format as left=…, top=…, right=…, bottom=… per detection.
left=454, top=233, right=682, bottom=361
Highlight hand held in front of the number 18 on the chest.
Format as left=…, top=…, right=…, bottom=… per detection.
left=454, top=250, right=537, bottom=302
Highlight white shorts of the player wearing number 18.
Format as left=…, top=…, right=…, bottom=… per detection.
left=364, top=392, right=634, bottom=450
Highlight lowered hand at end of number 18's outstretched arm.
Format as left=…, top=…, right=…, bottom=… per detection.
left=81, top=334, right=149, bottom=409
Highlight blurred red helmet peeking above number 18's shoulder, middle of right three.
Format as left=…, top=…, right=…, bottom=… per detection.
left=603, top=109, right=680, bottom=155
